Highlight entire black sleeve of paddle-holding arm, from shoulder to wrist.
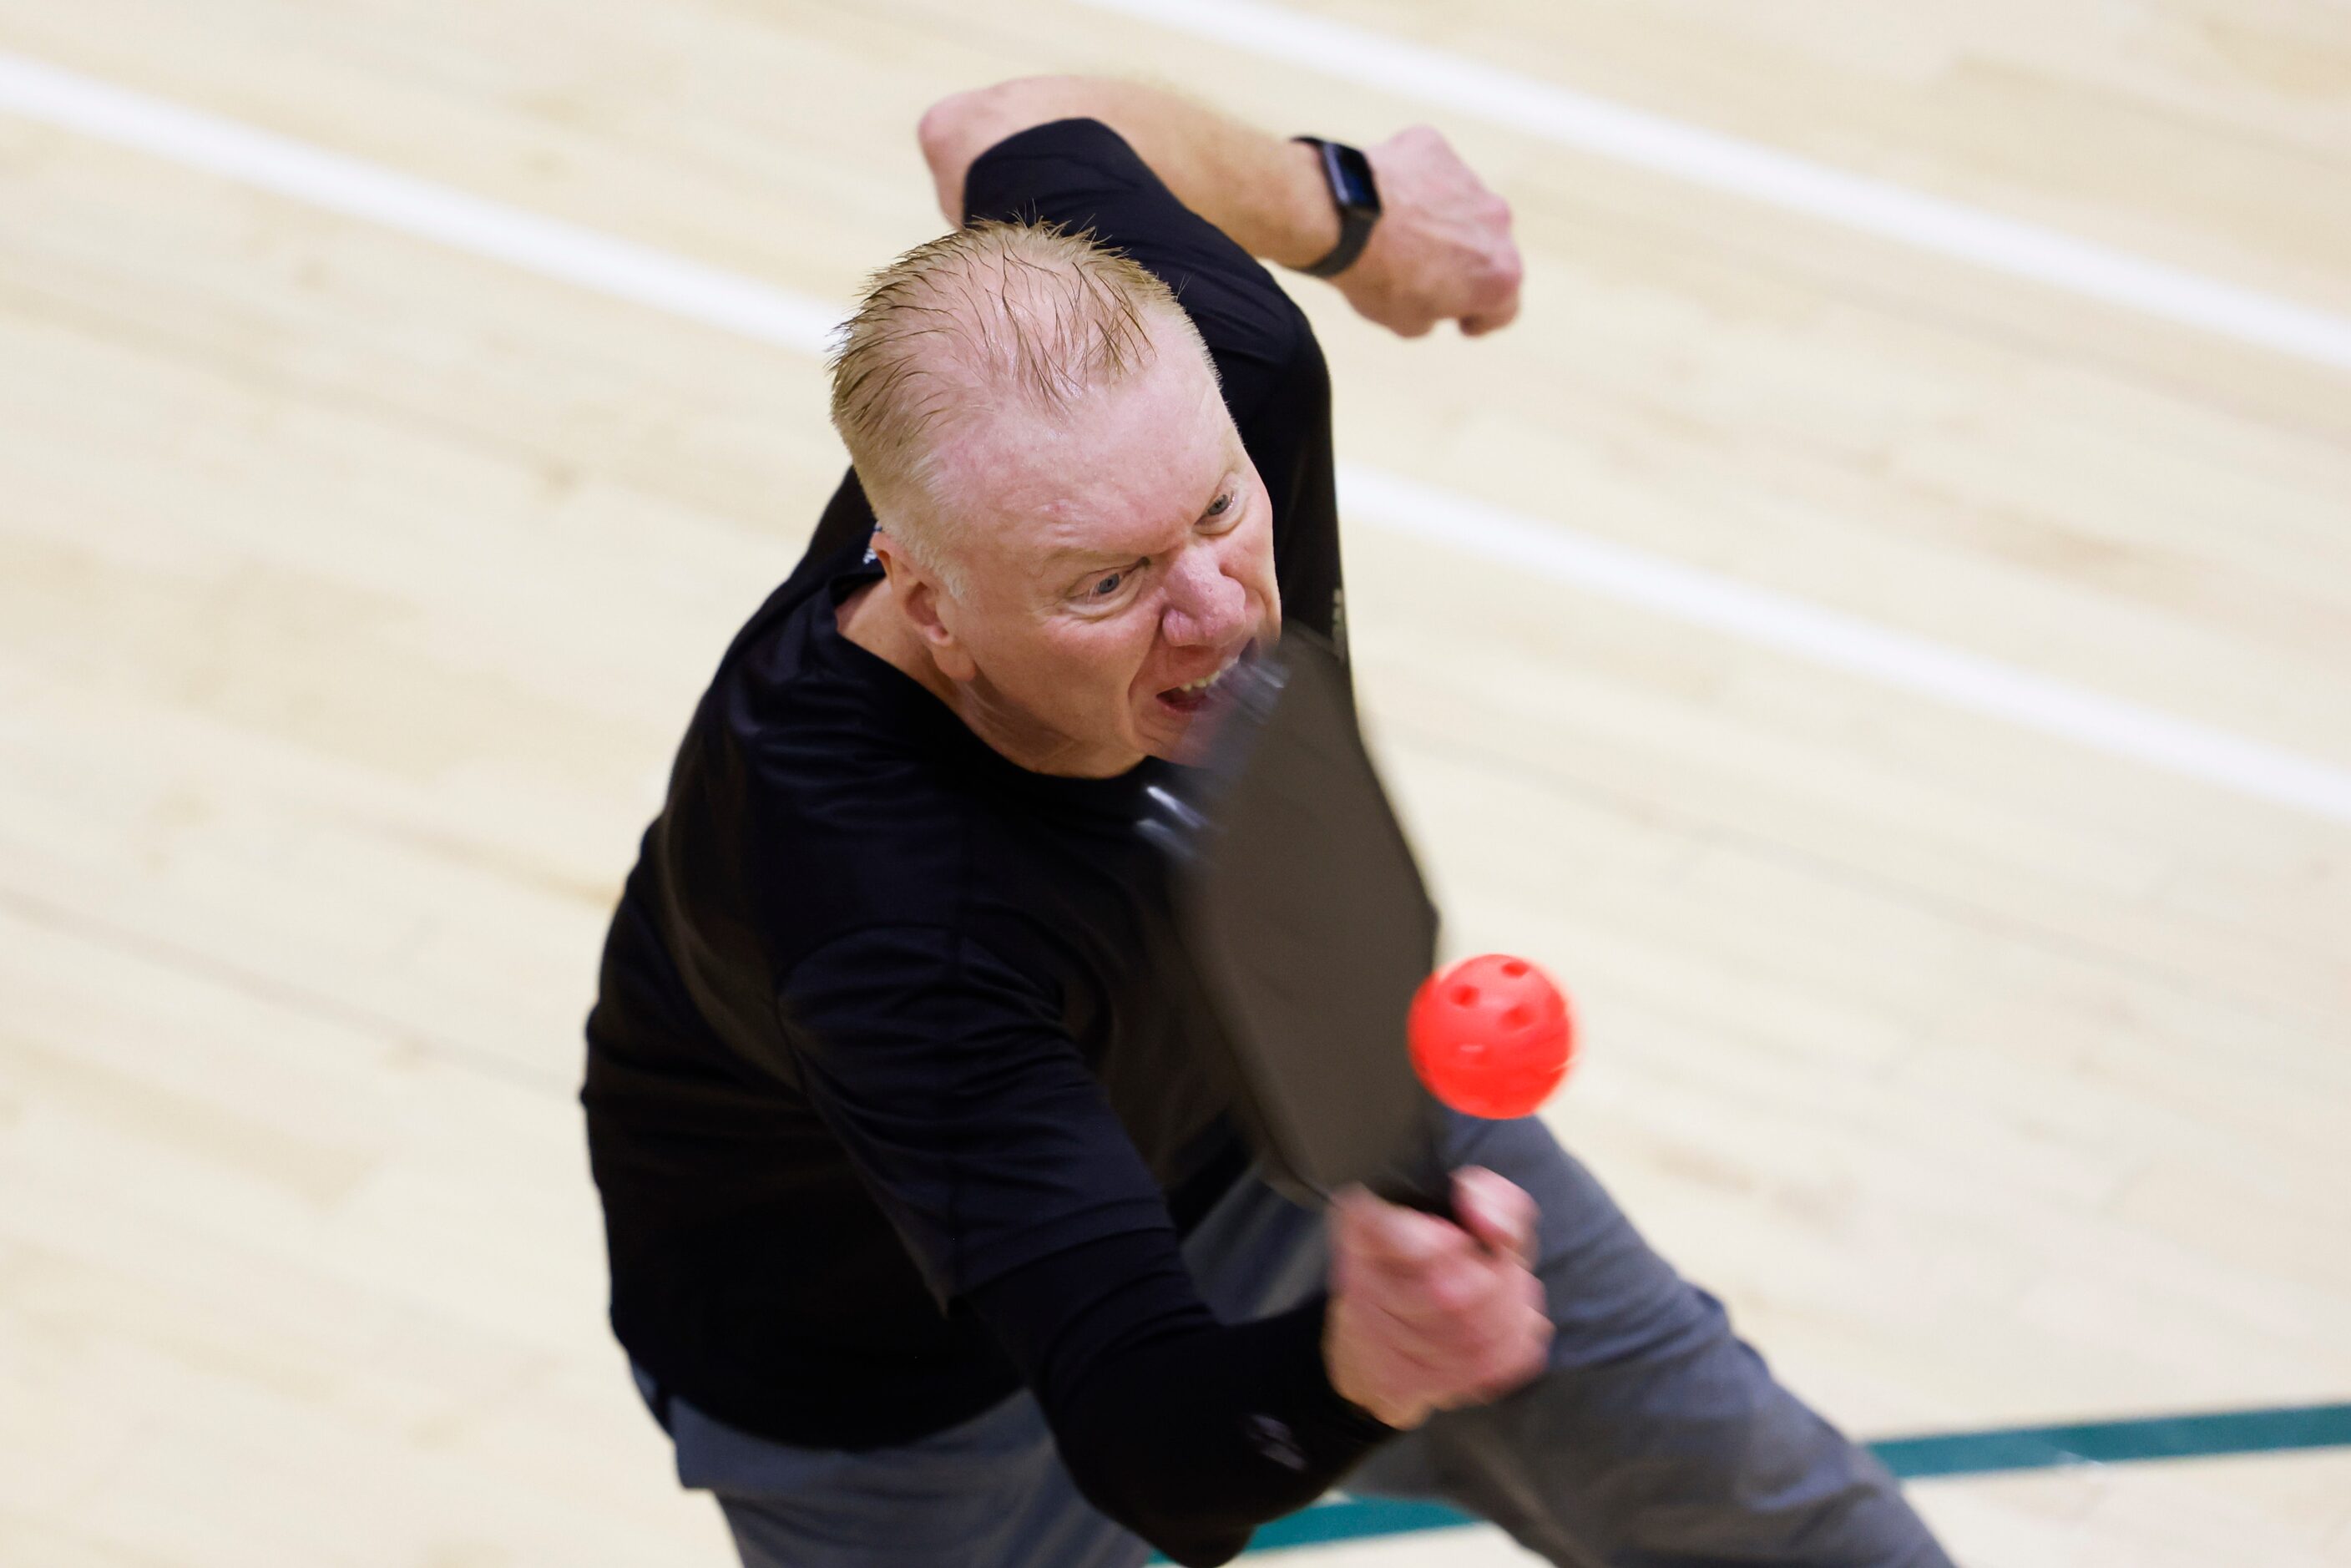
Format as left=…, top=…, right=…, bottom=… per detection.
left=783, top=926, right=1389, bottom=1563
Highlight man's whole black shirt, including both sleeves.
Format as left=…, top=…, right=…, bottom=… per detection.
left=583, top=120, right=1385, bottom=1563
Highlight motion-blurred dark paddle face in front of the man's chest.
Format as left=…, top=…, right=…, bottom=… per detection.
left=1145, top=630, right=1443, bottom=1206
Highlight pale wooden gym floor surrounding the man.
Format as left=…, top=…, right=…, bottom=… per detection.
left=0, top=0, right=2351, bottom=1568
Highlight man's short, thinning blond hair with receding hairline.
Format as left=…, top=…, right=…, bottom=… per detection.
left=830, top=221, right=1213, bottom=590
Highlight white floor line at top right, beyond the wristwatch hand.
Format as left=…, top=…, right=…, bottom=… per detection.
left=1077, top=0, right=2351, bottom=369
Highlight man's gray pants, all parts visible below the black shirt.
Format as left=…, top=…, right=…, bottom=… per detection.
left=637, top=1116, right=1949, bottom=1568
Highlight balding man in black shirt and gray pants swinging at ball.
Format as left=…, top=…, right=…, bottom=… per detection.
left=583, top=80, right=1947, bottom=1568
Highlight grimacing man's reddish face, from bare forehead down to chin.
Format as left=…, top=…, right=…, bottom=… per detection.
left=907, top=322, right=1282, bottom=778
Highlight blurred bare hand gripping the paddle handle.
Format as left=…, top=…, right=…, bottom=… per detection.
left=1323, top=1168, right=1552, bottom=1427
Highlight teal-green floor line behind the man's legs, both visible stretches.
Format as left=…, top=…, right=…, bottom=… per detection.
left=1176, top=1404, right=2351, bottom=1561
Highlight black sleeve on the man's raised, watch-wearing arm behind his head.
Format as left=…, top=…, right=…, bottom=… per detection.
left=964, top=120, right=1345, bottom=651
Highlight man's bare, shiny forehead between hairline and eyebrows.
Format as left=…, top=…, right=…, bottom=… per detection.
left=931, top=331, right=1241, bottom=567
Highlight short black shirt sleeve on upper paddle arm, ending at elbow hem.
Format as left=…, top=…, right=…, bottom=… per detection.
left=781, top=926, right=1173, bottom=1302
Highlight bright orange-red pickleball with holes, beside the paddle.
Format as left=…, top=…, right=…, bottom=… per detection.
left=1403, top=952, right=1575, bottom=1121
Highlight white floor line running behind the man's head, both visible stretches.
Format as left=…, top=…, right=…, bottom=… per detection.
left=0, top=52, right=2351, bottom=822
